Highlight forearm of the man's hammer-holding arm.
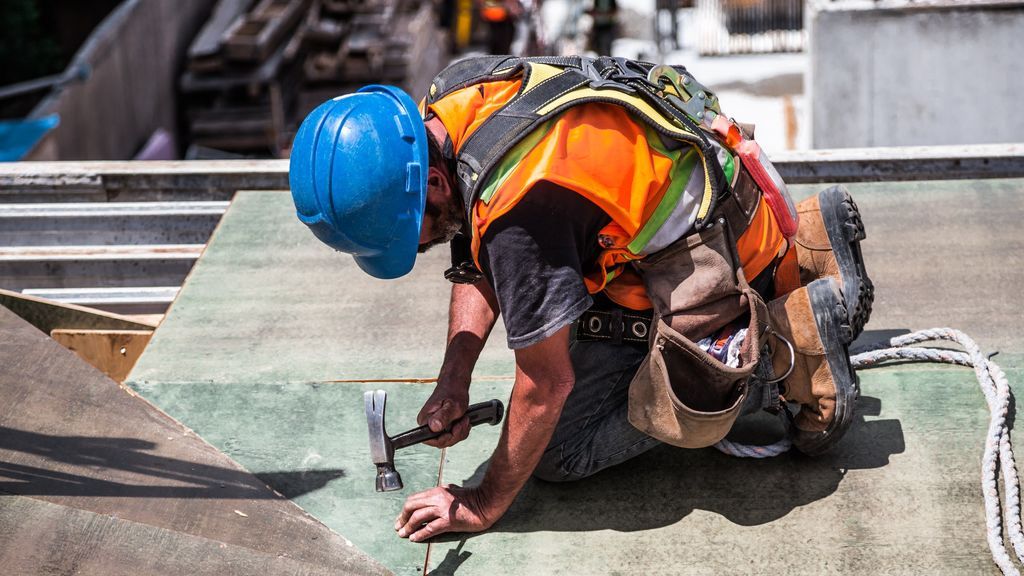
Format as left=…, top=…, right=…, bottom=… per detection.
left=438, top=280, right=498, bottom=385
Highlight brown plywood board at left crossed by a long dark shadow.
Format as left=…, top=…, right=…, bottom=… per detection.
left=0, top=307, right=384, bottom=573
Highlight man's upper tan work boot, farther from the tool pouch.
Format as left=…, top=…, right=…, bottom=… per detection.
left=797, top=186, right=874, bottom=343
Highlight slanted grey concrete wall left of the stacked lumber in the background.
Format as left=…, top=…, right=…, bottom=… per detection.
left=27, top=0, right=213, bottom=160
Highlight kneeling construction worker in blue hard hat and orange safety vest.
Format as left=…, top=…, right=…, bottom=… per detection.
left=290, top=57, right=872, bottom=541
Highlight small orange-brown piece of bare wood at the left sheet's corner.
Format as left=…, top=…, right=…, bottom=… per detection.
left=50, top=329, right=153, bottom=382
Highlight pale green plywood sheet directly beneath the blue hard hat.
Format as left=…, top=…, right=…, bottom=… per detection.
left=129, top=192, right=512, bottom=383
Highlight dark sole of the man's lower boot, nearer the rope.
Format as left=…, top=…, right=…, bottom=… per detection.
left=794, top=278, right=859, bottom=456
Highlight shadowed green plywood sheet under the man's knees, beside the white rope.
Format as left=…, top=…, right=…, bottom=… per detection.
left=428, top=366, right=1024, bottom=576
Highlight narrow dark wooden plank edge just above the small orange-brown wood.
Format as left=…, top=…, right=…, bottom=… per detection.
left=0, top=289, right=157, bottom=334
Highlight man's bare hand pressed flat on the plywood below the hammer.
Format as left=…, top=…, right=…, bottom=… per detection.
left=394, top=484, right=508, bottom=542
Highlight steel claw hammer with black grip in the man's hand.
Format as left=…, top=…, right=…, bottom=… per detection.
left=362, top=390, right=505, bottom=492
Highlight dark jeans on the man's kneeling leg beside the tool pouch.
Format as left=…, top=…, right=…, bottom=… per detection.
left=534, top=341, right=660, bottom=482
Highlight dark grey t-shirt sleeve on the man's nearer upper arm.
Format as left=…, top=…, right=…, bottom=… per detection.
left=480, top=181, right=610, bottom=348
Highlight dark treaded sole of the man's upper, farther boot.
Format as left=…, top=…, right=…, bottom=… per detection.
left=818, top=186, right=874, bottom=344
